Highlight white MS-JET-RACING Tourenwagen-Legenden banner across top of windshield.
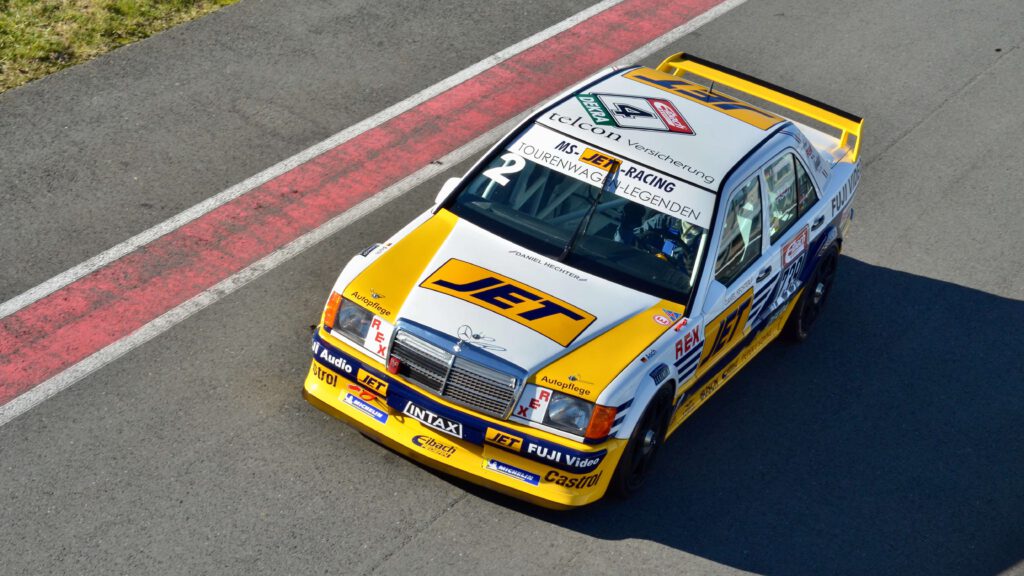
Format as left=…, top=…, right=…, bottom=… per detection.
left=495, top=126, right=715, bottom=229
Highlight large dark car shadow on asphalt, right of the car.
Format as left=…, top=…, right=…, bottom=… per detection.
left=481, top=257, right=1024, bottom=575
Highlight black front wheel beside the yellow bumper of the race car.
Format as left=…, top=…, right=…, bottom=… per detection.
left=609, top=388, right=672, bottom=498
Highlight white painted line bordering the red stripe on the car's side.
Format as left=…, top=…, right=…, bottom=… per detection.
left=0, top=0, right=746, bottom=426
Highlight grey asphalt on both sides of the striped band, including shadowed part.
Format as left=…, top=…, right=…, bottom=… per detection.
left=0, top=0, right=1024, bottom=575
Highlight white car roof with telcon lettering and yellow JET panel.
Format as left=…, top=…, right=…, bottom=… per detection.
left=537, top=67, right=788, bottom=191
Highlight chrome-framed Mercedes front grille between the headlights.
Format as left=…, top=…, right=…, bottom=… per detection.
left=391, top=330, right=516, bottom=418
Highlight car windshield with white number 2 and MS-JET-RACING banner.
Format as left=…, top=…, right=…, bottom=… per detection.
left=450, top=126, right=710, bottom=302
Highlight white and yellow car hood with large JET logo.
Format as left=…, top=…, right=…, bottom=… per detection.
left=344, top=210, right=683, bottom=397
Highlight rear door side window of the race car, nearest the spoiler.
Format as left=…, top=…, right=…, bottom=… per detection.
left=764, top=154, right=818, bottom=244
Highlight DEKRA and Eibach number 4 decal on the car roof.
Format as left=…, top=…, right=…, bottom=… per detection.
left=577, top=93, right=694, bottom=135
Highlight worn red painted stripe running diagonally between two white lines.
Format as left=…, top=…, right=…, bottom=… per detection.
left=0, top=0, right=722, bottom=405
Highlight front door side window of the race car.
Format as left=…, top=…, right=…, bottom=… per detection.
left=715, top=175, right=761, bottom=286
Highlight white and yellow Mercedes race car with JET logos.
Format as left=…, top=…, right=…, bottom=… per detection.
left=303, top=53, right=863, bottom=508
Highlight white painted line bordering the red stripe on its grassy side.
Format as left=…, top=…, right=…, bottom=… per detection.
left=0, top=0, right=623, bottom=318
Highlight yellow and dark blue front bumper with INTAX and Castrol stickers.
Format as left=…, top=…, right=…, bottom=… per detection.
left=302, top=330, right=626, bottom=509
